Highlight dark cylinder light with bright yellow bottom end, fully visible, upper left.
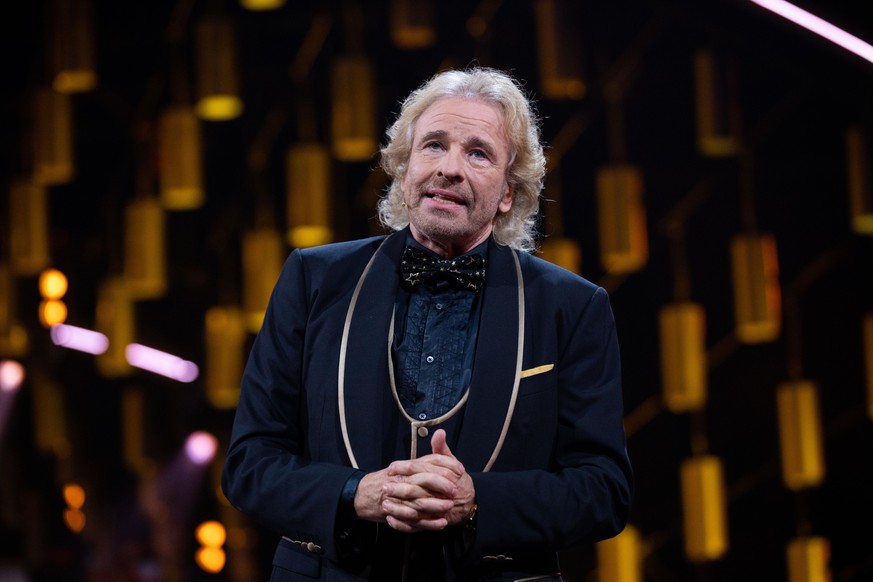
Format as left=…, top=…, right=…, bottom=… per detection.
left=196, top=13, right=243, bottom=121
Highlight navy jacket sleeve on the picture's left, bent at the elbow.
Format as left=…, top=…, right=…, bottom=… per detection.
left=222, top=250, right=368, bottom=560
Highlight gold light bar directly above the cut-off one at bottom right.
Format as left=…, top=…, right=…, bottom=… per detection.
left=776, top=380, right=825, bottom=491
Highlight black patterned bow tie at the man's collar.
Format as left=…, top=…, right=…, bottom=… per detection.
left=400, top=246, right=485, bottom=291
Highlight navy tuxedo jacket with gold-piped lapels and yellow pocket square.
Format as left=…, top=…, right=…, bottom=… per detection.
left=222, top=231, right=632, bottom=582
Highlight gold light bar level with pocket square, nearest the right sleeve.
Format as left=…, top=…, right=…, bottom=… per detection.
left=658, top=301, right=707, bottom=413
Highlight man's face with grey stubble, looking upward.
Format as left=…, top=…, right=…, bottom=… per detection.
left=400, top=97, right=512, bottom=256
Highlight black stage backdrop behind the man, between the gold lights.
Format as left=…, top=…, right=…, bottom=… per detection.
left=0, top=0, right=873, bottom=582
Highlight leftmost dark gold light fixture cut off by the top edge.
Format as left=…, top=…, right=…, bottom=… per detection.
left=49, top=0, right=97, bottom=93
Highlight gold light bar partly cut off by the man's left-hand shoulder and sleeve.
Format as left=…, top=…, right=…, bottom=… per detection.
left=242, top=227, right=285, bottom=333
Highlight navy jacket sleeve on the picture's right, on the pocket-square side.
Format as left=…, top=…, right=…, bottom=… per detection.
left=472, top=288, right=633, bottom=556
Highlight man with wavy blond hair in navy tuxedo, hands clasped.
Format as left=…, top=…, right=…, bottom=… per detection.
left=223, top=68, right=632, bottom=582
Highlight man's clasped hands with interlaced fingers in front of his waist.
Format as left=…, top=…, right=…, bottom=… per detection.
left=355, top=429, right=476, bottom=533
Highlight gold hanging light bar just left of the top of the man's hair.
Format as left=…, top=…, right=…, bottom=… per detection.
left=331, top=54, right=377, bottom=162
